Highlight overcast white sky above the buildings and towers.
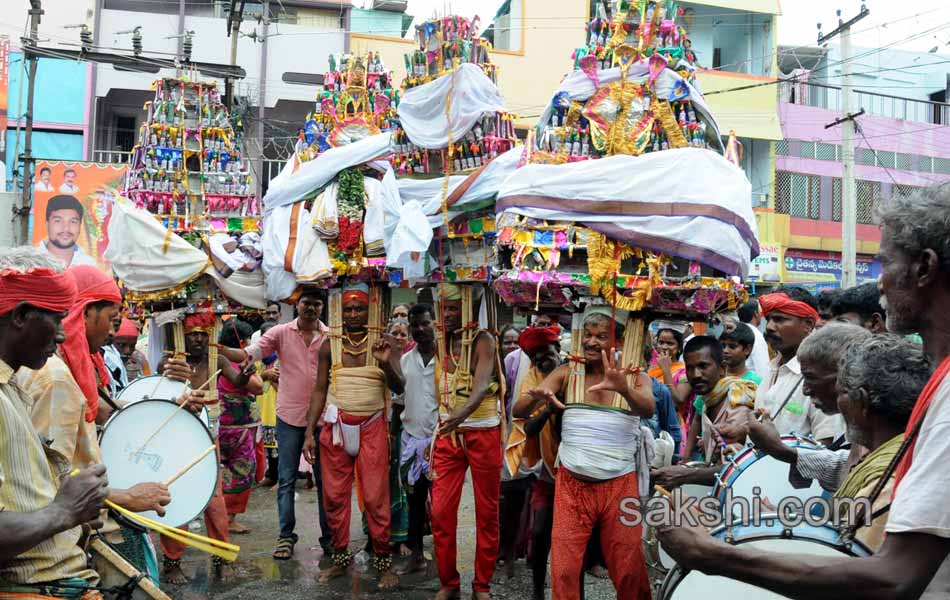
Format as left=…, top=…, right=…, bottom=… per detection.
left=388, top=0, right=950, bottom=54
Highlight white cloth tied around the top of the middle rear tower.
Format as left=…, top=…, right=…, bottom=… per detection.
left=397, top=63, right=505, bottom=150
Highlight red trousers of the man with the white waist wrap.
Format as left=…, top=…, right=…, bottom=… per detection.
left=551, top=467, right=651, bottom=600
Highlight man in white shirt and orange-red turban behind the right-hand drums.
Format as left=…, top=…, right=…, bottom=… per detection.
left=755, top=286, right=844, bottom=444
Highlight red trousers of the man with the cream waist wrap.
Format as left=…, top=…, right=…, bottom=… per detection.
left=320, top=411, right=391, bottom=556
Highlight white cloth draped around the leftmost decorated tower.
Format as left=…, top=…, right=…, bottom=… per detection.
left=105, top=198, right=266, bottom=308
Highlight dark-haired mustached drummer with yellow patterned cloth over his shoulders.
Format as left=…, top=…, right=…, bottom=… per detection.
left=651, top=335, right=756, bottom=487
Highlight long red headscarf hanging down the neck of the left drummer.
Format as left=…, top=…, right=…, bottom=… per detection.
left=60, top=265, right=122, bottom=423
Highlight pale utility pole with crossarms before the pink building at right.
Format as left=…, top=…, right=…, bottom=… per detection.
left=818, top=2, right=870, bottom=288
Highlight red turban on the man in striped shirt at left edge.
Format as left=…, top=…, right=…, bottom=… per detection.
left=0, top=267, right=76, bottom=315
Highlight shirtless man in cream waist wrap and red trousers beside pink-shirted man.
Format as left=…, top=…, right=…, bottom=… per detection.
left=304, top=284, right=403, bottom=589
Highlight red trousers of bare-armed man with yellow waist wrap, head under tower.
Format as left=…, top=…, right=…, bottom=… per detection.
left=432, top=427, right=502, bottom=592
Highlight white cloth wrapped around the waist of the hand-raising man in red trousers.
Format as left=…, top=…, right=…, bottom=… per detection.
left=558, top=404, right=653, bottom=489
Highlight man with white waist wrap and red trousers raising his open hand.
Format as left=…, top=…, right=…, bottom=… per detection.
left=528, top=307, right=655, bottom=600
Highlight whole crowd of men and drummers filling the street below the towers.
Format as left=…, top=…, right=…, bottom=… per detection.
left=0, top=187, right=950, bottom=600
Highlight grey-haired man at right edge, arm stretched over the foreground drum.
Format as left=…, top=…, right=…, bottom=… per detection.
left=659, top=185, right=950, bottom=600
